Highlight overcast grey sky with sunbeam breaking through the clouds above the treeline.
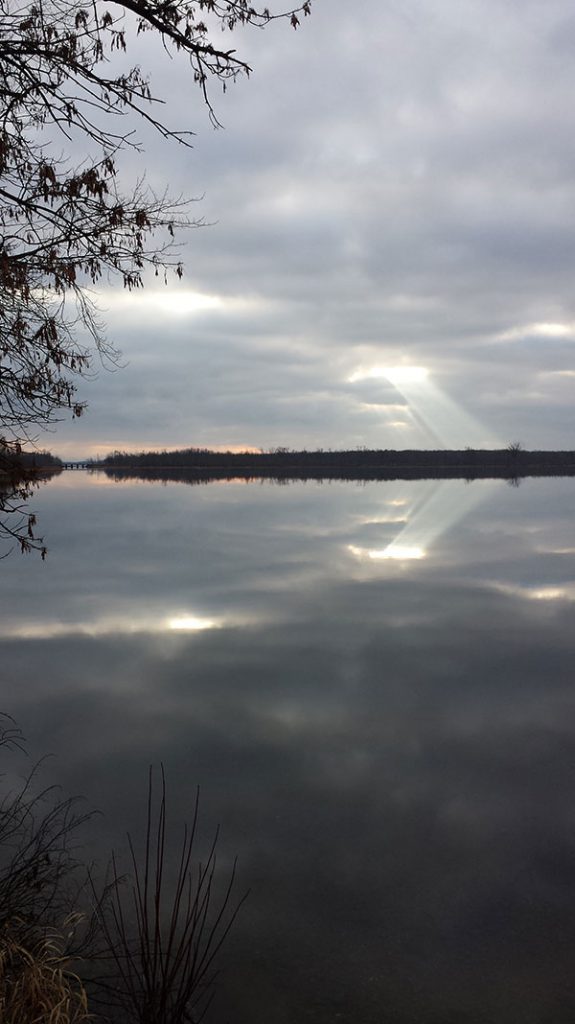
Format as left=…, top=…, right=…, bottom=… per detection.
left=39, top=0, right=575, bottom=458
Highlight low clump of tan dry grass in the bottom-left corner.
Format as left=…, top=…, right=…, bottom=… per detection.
left=0, top=929, right=92, bottom=1024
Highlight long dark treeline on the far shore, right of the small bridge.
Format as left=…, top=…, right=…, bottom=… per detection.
left=87, top=443, right=575, bottom=483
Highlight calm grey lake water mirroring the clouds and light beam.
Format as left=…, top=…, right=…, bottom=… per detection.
left=0, top=472, right=575, bottom=1024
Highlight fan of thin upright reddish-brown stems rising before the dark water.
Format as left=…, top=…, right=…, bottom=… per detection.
left=93, top=766, right=248, bottom=1024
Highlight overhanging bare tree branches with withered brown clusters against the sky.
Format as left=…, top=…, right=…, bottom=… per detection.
left=0, top=0, right=311, bottom=446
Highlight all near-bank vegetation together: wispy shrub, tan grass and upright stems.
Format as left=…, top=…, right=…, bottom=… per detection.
left=0, top=713, right=239, bottom=1024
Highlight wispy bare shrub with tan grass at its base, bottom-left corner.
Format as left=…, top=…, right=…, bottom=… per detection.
left=0, top=715, right=93, bottom=1024
